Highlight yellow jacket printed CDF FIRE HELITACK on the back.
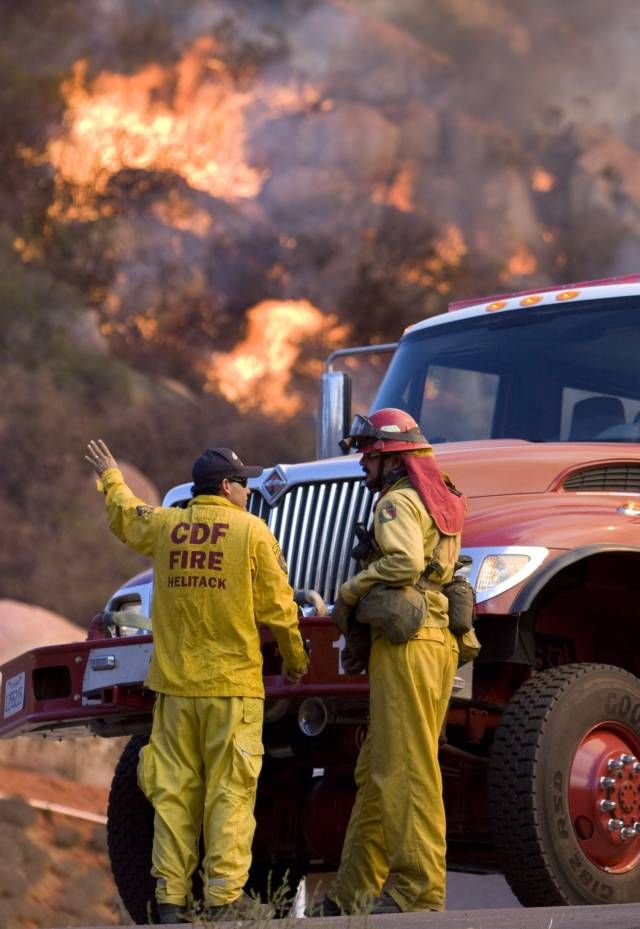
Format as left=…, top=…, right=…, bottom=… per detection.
left=102, top=468, right=308, bottom=697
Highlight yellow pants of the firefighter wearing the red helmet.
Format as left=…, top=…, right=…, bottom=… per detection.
left=329, top=628, right=458, bottom=913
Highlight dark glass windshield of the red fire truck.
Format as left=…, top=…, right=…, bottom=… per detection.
left=372, top=296, right=640, bottom=443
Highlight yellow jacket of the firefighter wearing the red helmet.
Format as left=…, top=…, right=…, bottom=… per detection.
left=340, top=477, right=460, bottom=627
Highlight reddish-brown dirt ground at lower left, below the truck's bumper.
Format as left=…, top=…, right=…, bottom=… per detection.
left=0, top=766, right=122, bottom=929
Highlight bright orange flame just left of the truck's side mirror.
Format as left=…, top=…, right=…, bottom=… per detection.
left=204, top=300, right=349, bottom=419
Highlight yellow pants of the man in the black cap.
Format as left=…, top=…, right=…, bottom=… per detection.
left=138, top=694, right=263, bottom=906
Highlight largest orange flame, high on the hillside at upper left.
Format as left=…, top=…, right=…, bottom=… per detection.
left=46, top=36, right=264, bottom=219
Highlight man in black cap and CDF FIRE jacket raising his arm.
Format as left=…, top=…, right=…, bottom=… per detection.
left=85, top=440, right=308, bottom=923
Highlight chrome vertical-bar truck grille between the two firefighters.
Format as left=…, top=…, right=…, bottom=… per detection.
left=249, top=478, right=373, bottom=603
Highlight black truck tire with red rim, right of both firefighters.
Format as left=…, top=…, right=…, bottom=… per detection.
left=489, top=663, right=640, bottom=906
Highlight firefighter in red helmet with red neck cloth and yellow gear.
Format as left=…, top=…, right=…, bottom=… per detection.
left=309, top=409, right=465, bottom=916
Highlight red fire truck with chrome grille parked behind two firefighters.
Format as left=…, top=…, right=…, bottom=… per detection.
left=0, top=275, right=640, bottom=923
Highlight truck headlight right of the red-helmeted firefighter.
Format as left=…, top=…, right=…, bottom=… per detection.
left=462, top=545, right=549, bottom=603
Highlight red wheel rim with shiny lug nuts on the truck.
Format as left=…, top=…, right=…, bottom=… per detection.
left=569, top=722, right=640, bottom=874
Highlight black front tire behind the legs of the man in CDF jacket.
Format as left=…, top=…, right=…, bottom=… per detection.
left=107, top=735, right=306, bottom=925
